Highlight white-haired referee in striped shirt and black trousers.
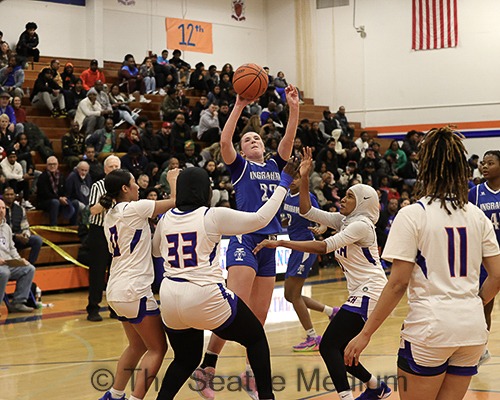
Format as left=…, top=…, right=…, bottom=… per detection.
left=86, top=156, right=121, bottom=322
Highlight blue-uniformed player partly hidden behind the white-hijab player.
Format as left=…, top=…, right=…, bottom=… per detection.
left=282, top=173, right=339, bottom=352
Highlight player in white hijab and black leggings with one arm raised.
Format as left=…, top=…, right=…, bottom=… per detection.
left=254, top=148, right=391, bottom=400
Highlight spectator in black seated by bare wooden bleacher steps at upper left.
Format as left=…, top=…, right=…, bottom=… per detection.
left=30, top=68, right=68, bottom=118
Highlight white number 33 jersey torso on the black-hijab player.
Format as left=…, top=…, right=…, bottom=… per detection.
left=153, top=207, right=224, bottom=286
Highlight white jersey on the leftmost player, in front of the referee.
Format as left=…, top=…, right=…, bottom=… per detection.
left=104, top=200, right=155, bottom=302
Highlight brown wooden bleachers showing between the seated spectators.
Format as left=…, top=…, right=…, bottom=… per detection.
left=20, top=56, right=390, bottom=291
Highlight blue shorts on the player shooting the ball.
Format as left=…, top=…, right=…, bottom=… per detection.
left=226, top=233, right=276, bottom=277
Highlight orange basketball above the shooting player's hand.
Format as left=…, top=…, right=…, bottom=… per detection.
left=233, top=63, right=269, bottom=99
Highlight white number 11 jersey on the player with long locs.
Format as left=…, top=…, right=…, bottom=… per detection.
left=383, top=198, right=500, bottom=347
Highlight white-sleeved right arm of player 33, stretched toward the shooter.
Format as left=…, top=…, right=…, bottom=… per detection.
left=205, top=186, right=287, bottom=235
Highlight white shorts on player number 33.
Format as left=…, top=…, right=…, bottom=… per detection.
left=160, top=278, right=238, bottom=331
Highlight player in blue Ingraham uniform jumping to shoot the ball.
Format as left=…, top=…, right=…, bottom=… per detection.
left=196, top=85, right=299, bottom=399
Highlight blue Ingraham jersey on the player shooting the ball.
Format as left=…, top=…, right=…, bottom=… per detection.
left=227, top=154, right=286, bottom=235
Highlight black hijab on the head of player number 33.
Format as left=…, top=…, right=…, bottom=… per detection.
left=175, top=167, right=210, bottom=211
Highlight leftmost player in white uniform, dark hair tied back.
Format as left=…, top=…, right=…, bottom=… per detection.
left=99, top=169, right=179, bottom=400
